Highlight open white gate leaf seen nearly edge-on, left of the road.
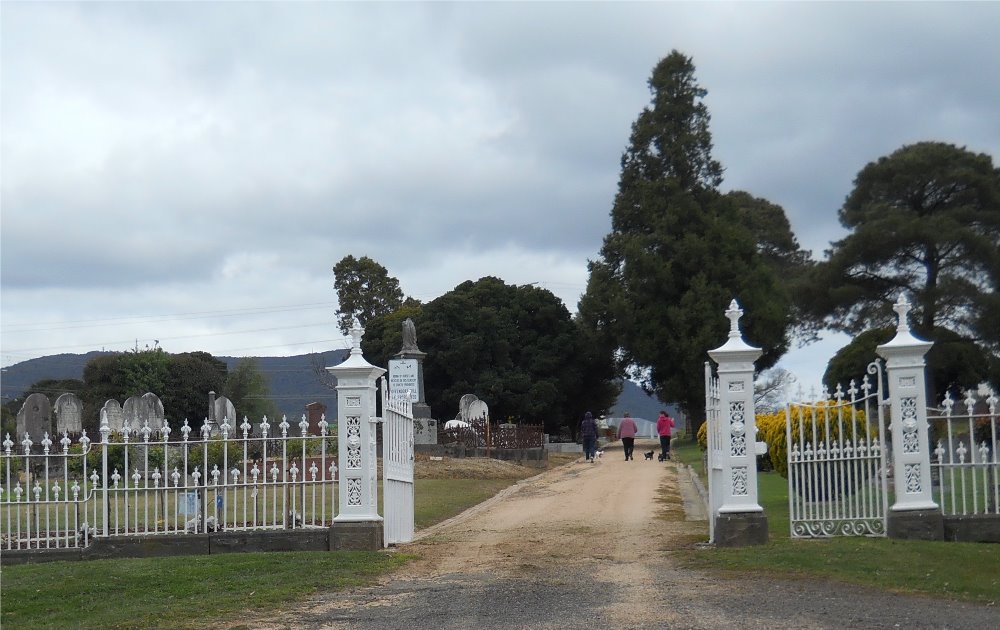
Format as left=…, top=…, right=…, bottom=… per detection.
left=382, top=378, right=413, bottom=547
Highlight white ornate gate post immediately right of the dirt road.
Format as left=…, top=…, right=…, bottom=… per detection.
left=708, top=300, right=767, bottom=546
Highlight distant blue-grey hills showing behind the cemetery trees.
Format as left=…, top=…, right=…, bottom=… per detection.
left=0, top=350, right=683, bottom=426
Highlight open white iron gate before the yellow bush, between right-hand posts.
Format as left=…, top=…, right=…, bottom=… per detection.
left=785, top=361, right=888, bottom=538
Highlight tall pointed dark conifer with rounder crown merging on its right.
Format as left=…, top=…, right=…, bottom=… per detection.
left=579, top=51, right=808, bottom=428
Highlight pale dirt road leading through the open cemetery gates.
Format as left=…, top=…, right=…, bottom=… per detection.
left=250, top=441, right=1000, bottom=630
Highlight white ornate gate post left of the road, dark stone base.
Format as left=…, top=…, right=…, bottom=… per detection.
left=326, top=318, right=385, bottom=550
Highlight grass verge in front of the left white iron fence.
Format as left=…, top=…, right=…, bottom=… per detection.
left=0, top=551, right=407, bottom=628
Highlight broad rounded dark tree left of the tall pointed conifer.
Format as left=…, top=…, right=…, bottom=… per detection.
left=363, top=277, right=617, bottom=432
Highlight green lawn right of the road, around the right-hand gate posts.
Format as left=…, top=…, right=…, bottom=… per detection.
left=672, top=442, right=1000, bottom=604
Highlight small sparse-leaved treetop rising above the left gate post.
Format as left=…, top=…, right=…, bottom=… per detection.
left=333, top=255, right=403, bottom=335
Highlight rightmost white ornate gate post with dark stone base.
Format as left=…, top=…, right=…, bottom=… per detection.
left=877, top=295, right=944, bottom=540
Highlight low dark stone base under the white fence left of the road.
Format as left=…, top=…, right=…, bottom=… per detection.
left=3, top=521, right=382, bottom=565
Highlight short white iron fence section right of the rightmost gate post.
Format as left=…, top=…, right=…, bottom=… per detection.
left=927, top=390, right=1000, bottom=516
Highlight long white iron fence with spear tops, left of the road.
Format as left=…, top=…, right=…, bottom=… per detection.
left=0, top=416, right=337, bottom=550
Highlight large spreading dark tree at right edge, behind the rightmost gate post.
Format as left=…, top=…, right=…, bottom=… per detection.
left=800, top=142, right=1000, bottom=396
